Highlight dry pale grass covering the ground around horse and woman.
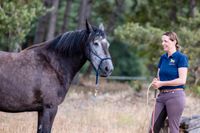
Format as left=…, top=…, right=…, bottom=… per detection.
left=0, top=81, right=200, bottom=133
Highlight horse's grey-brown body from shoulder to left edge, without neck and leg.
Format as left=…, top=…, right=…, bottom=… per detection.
left=0, top=49, right=62, bottom=111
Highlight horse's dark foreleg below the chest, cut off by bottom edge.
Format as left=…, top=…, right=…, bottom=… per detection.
left=37, top=106, right=58, bottom=133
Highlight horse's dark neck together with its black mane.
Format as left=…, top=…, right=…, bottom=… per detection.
left=40, top=30, right=88, bottom=83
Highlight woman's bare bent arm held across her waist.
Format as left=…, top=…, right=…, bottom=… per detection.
left=152, top=67, right=188, bottom=89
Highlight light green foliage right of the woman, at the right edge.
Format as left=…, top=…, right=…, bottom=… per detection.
left=178, top=11, right=200, bottom=69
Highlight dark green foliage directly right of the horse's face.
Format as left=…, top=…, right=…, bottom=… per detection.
left=110, top=40, right=146, bottom=76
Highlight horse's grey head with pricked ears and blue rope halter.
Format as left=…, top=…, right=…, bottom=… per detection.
left=86, top=21, right=113, bottom=77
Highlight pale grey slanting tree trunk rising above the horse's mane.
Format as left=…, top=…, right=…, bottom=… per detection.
left=46, top=0, right=59, bottom=40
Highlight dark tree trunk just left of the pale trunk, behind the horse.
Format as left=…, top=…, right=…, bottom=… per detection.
left=33, top=0, right=52, bottom=44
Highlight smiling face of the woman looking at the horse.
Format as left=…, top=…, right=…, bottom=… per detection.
left=162, top=35, right=176, bottom=52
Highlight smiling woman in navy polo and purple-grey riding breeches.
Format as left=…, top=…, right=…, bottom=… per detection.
left=150, top=32, right=188, bottom=133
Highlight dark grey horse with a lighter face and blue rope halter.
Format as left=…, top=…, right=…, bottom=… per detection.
left=0, top=21, right=113, bottom=133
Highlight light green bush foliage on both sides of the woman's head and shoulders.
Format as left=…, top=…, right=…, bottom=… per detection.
left=115, top=17, right=200, bottom=83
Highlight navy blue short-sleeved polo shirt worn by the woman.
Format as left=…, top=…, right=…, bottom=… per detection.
left=158, top=51, right=188, bottom=90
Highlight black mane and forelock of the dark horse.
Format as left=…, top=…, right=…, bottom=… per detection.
left=23, top=26, right=105, bottom=56
